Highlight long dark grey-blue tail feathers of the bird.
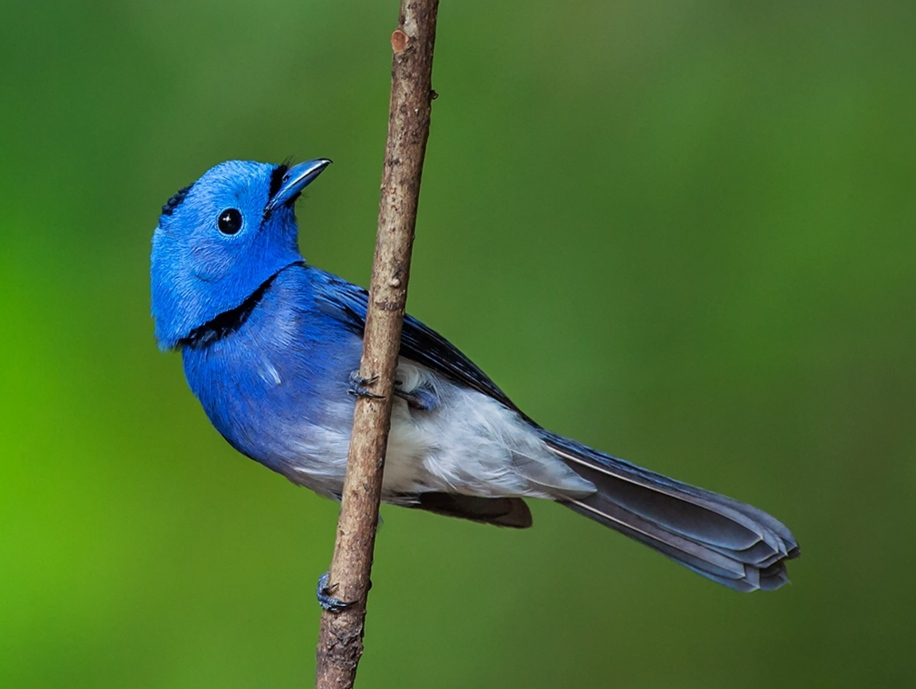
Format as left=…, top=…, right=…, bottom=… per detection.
left=544, top=431, right=800, bottom=591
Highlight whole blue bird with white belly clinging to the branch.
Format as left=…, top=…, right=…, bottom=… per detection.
left=151, top=159, right=799, bottom=607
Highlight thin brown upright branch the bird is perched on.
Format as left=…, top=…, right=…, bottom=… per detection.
left=315, top=0, right=439, bottom=689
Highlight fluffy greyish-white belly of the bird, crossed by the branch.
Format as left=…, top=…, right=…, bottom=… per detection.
left=284, top=359, right=595, bottom=503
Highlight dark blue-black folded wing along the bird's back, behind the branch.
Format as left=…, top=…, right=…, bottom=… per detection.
left=308, top=266, right=527, bottom=418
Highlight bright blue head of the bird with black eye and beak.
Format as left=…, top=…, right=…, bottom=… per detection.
left=150, top=158, right=331, bottom=349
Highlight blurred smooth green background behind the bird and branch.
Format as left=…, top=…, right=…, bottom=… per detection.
left=0, top=0, right=916, bottom=689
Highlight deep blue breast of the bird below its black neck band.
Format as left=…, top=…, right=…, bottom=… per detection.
left=182, top=265, right=362, bottom=474
